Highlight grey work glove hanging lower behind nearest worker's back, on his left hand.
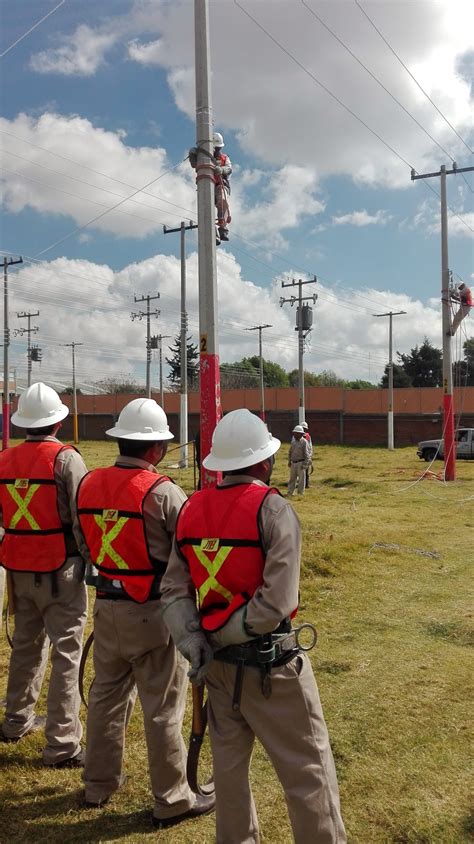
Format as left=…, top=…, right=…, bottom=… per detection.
left=163, top=598, right=213, bottom=685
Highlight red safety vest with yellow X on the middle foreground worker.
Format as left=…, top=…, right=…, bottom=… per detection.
left=77, top=466, right=170, bottom=604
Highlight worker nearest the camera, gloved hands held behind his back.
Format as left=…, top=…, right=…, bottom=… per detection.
left=161, top=409, right=346, bottom=844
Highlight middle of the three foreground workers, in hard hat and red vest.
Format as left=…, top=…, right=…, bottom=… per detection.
left=77, top=399, right=214, bottom=828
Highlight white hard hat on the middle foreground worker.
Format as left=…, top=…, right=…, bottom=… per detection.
left=105, top=399, right=174, bottom=442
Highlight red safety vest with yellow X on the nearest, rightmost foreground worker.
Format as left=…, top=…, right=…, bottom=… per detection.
left=176, top=483, right=279, bottom=630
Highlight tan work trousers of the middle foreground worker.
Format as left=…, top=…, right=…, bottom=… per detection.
left=84, top=599, right=195, bottom=818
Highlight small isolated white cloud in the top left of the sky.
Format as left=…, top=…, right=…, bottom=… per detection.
left=30, top=24, right=118, bottom=76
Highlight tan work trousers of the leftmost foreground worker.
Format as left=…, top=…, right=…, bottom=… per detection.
left=2, top=557, right=87, bottom=765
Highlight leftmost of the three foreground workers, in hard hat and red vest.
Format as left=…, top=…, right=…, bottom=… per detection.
left=0, top=383, right=87, bottom=768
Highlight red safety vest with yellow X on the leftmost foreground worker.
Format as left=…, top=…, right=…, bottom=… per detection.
left=0, top=440, right=73, bottom=573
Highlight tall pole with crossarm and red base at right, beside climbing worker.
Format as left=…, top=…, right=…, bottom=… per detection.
left=411, top=163, right=474, bottom=481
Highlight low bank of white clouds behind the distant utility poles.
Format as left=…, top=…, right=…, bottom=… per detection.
left=11, top=252, right=462, bottom=392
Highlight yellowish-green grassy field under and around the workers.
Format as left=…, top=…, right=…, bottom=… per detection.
left=0, top=443, right=474, bottom=844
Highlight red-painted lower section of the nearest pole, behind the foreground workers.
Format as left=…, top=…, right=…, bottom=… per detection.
left=199, top=352, right=222, bottom=489
